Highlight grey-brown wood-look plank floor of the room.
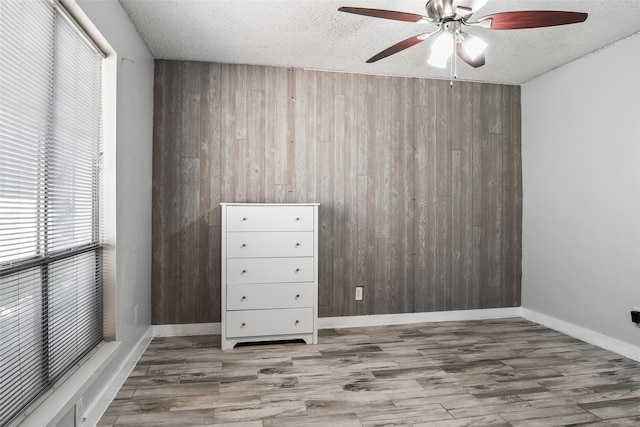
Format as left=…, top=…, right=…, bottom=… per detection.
left=99, top=319, right=640, bottom=427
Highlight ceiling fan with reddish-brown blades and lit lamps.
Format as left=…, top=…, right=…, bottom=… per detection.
left=338, top=0, right=587, bottom=68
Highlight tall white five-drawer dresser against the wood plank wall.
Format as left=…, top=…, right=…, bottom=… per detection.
left=221, top=203, right=318, bottom=349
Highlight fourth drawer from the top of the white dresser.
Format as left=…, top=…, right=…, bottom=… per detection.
left=227, top=282, right=313, bottom=310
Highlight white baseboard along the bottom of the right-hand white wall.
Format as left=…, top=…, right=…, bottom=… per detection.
left=520, top=307, right=640, bottom=362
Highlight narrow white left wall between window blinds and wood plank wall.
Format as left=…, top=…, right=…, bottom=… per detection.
left=77, top=0, right=154, bottom=425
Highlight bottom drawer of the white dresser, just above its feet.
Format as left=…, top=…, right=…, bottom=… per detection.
left=226, top=308, right=313, bottom=338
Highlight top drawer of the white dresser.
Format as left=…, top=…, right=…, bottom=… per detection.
left=226, top=205, right=314, bottom=231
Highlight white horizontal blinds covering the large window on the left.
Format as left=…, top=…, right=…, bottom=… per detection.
left=0, top=0, right=102, bottom=425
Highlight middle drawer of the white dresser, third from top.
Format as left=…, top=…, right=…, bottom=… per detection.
left=223, top=257, right=314, bottom=286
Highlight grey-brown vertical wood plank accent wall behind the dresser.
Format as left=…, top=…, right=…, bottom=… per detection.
left=152, top=60, right=522, bottom=324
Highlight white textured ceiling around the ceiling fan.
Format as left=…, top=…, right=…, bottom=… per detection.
left=119, top=0, right=640, bottom=84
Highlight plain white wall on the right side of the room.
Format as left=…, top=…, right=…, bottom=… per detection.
left=522, top=34, right=640, bottom=357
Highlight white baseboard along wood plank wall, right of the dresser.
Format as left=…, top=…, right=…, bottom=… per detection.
left=318, top=307, right=520, bottom=329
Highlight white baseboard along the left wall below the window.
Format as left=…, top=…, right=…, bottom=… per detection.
left=83, top=327, right=153, bottom=426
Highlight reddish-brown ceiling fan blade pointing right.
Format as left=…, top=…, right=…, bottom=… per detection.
left=478, top=10, right=588, bottom=30
